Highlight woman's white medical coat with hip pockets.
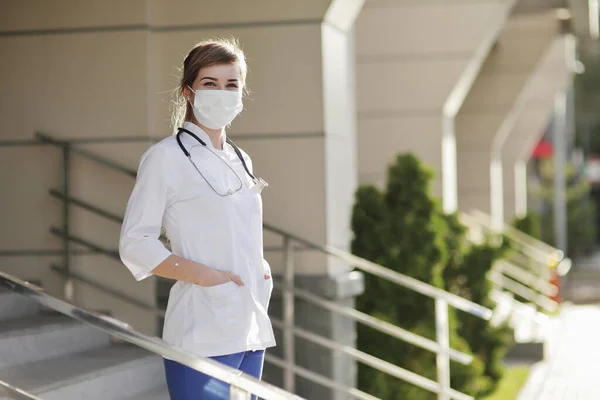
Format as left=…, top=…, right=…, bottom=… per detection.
left=119, top=122, right=275, bottom=357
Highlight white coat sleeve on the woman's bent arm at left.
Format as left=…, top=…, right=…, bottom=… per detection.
left=119, top=145, right=173, bottom=281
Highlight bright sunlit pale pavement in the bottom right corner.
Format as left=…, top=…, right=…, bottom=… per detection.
left=518, top=304, right=600, bottom=400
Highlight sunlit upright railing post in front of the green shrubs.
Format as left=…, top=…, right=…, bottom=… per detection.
left=435, top=297, right=450, bottom=400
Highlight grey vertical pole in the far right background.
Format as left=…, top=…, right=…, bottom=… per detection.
left=552, top=92, right=567, bottom=252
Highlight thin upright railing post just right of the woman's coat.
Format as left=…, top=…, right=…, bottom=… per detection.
left=283, top=236, right=296, bottom=393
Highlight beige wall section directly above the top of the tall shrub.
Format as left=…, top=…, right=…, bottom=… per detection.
left=356, top=0, right=510, bottom=206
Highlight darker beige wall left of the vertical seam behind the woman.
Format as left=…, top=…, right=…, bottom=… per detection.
left=0, top=1, right=154, bottom=331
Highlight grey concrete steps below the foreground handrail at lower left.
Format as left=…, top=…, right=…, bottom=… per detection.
left=0, top=288, right=169, bottom=400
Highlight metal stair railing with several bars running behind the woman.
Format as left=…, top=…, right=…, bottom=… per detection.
left=36, top=133, right=492, bottom=400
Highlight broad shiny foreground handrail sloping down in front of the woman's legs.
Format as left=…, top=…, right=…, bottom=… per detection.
left=0, top=271, right=302, bottom=400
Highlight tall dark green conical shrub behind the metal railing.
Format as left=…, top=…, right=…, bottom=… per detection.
left=352, top=154, right=489, bottom=400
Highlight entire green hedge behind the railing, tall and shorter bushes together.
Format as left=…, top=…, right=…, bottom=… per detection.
left=352, top=154, right=507, bottom=400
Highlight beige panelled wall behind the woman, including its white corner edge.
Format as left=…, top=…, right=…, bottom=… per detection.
left=0, top=0, right=362, bottom=331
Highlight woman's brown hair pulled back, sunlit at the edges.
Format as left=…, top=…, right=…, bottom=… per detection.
left=171, top=38, right=248, bottom=129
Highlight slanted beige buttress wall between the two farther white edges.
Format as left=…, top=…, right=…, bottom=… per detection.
left=457, top=11, right=566, bottom=219
